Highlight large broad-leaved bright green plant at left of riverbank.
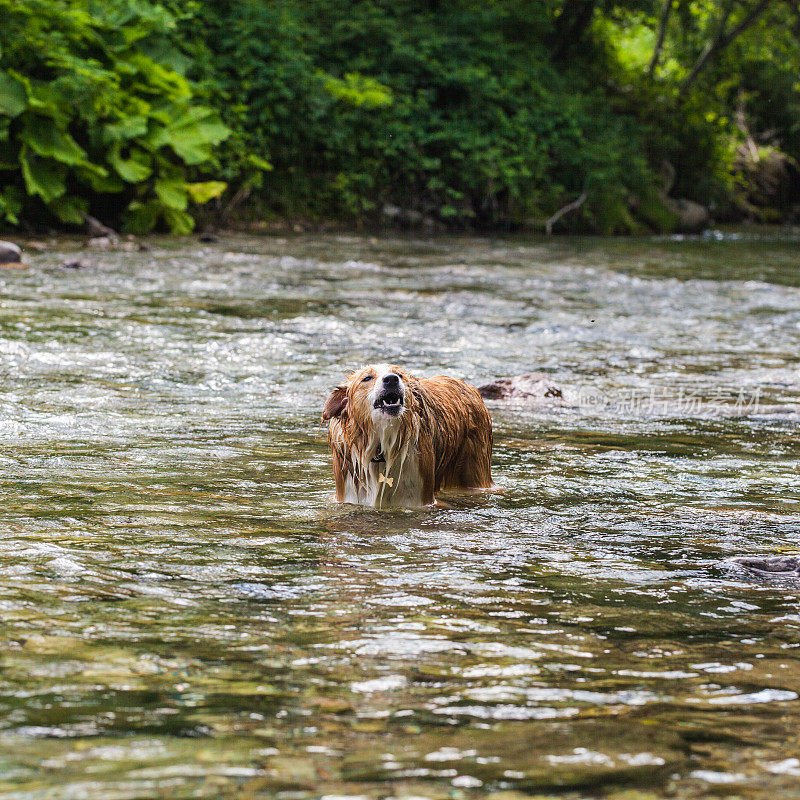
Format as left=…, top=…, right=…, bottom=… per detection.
left=0, top=0, right=229, bottom=233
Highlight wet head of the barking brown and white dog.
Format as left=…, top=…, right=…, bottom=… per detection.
left=322, top=364, right=416, bottom=431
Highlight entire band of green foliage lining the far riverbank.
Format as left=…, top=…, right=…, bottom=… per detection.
left=0, top=0, right=800, bottom=233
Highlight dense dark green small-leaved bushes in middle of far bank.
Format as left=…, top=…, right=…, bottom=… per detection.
left=191, top=0, right=654, bottom=231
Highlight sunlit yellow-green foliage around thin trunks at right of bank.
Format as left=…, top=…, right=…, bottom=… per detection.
left=595, top=0, right=800, bottom=218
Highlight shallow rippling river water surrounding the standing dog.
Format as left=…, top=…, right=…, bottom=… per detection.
left=0, top=236, right=800, bottom=800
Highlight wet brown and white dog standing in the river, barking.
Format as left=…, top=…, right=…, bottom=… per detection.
left=322, top=364, right=493, bottom=508
